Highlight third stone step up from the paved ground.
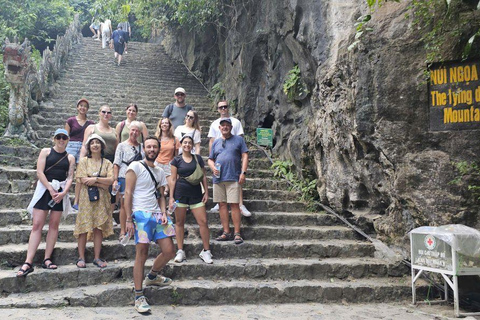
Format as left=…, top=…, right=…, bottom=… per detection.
left=0, top=239, right=375, bottom=266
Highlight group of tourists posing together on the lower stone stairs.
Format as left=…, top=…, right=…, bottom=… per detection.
left=17, top=88, right=251, bottom=313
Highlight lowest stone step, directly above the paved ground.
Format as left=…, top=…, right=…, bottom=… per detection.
left=0, top=271, right=428, bottom=308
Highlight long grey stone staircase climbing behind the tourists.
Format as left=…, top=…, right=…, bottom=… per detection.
left=0, top=38, right=422, bottom=308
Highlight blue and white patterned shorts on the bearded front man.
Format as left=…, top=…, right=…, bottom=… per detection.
left=132, top=211, right=175, bottom=244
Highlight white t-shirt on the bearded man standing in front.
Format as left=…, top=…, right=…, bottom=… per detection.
left=127, top=161, right=167, bottom=212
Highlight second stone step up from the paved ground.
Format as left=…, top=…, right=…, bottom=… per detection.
left=0, top=255, right=408, bottom=295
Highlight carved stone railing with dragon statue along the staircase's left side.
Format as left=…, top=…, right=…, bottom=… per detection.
left=3, top=15, right=82, bottom=141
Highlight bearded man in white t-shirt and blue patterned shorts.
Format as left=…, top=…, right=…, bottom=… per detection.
left=124, top=136, right=175, bottom=313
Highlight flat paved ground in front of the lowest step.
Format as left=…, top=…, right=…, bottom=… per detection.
left=0, top=303, right=480, bottom=320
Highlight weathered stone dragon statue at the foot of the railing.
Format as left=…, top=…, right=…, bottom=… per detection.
left=2, top=38, right=38, bottom=140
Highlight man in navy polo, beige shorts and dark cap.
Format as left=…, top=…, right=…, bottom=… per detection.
left=208, top=118, right=248, bottom=244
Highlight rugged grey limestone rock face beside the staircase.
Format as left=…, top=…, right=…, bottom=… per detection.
left=163, top=0, right=480, bottom=243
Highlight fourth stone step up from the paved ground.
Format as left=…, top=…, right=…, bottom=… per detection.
left=0, top=223, right=359, bottom=246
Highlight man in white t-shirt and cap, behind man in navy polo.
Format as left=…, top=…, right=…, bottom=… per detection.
left=208, top=100, right=252, bottom=217
